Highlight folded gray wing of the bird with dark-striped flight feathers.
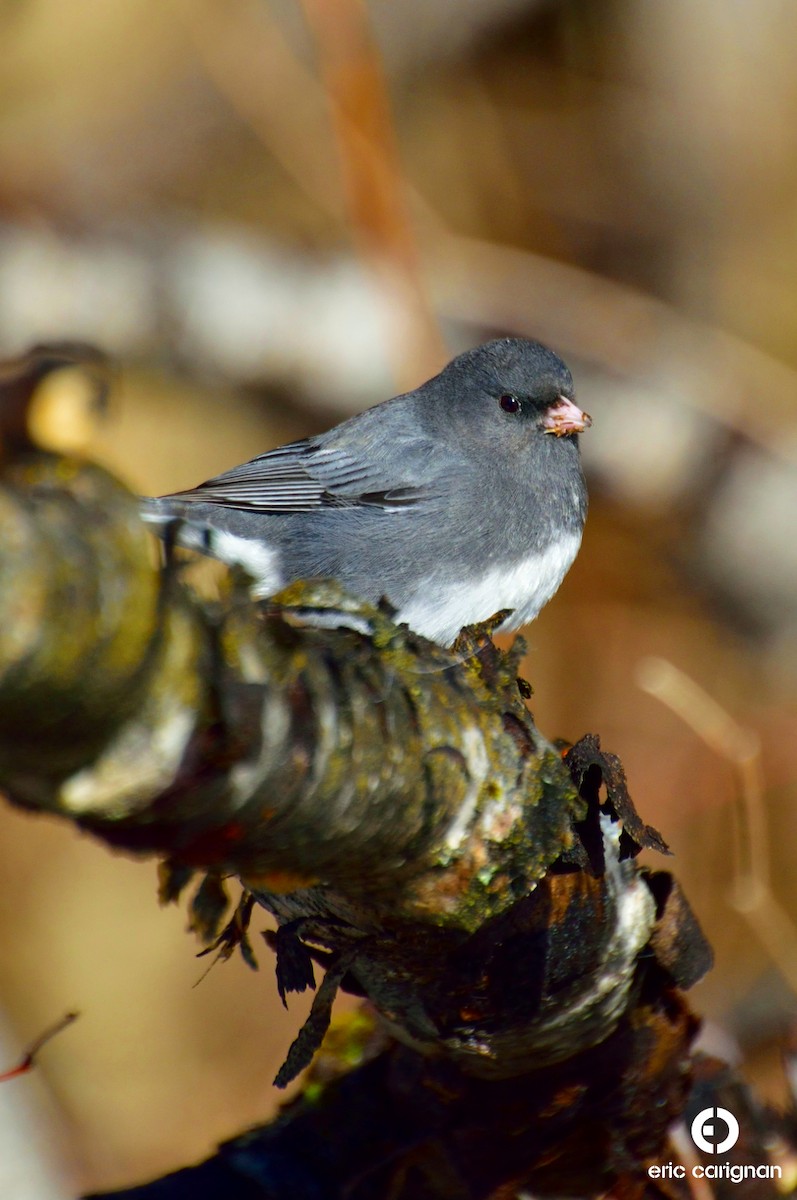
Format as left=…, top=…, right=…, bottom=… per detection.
left=168, top=436, right=441, bottom=514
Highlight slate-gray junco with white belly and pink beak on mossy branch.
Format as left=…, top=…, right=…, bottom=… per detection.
left=143, top=337, right=591, bottom=646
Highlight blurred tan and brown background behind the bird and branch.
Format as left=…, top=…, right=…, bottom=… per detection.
left=0, top=0, right=797, bottom=1200
